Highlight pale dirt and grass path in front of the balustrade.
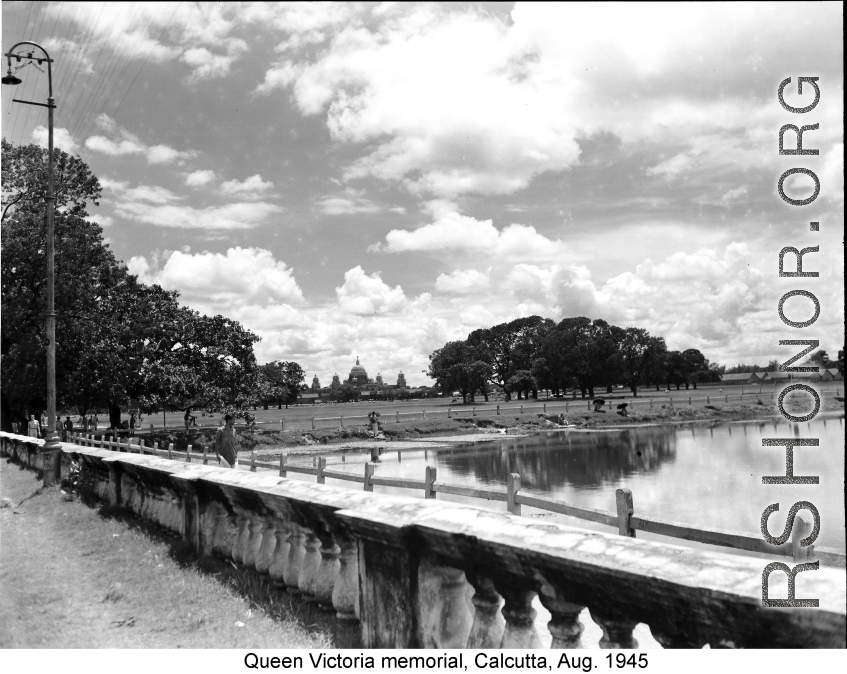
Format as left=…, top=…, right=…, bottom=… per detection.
left=0, top=459, right=330, bottom=648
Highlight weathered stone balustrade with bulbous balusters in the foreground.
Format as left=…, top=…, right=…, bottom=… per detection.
left=2, top=434, right=845, bottom=649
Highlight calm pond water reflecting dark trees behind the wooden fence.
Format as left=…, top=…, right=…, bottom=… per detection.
left=322, top=417, right=845, bottom=554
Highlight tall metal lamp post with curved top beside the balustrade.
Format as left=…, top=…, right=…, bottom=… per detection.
left=2, top=41, right=59, bottom=486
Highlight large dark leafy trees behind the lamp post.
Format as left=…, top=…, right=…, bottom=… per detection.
left=0, top=139, right=304, bottom=427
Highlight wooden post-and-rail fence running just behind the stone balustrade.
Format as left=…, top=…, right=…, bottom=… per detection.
left=58, top=434, right=847, bottom=568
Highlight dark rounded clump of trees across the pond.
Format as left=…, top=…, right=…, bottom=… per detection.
left=428, top=316, right=720, bottom=402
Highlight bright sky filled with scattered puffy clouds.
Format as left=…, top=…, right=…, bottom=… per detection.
left=0, top=2, right=844, bottom=386
